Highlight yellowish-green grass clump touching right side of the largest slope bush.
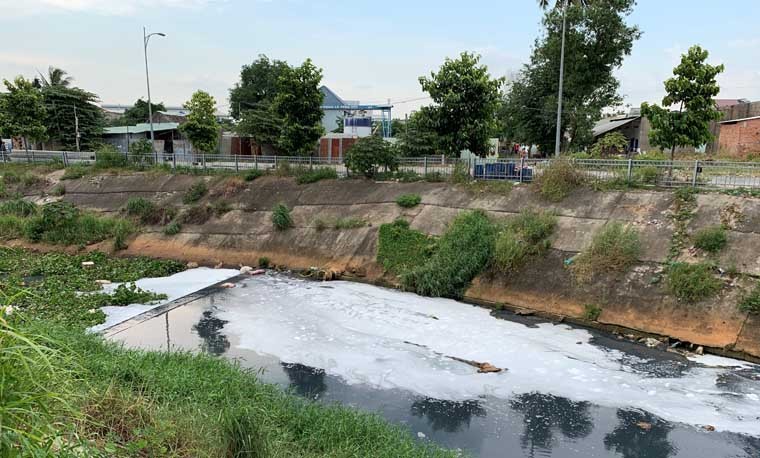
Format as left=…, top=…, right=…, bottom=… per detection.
left=493, top=210, right=557, bottom=273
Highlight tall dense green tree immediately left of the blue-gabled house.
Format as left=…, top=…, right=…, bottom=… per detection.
left=272, top=59, right=324, bottom=156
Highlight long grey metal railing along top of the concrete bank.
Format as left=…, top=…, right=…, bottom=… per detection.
left=2, top=150, right=760, bottom=189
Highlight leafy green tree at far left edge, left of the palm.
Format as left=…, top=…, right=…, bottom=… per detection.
left=0, top=76, right=47, bottom=149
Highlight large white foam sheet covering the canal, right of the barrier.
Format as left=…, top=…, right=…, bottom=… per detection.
left=217, top=276, right=760, bottom=435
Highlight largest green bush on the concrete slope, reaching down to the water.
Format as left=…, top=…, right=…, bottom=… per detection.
left=401, top=210, right=496, bottom=299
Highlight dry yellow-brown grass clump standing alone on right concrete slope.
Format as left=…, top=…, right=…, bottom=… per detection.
left=570, top=222, right=641, bottom=283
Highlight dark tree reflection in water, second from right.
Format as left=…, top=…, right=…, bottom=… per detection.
left=510, top=393, right=594, bottom=456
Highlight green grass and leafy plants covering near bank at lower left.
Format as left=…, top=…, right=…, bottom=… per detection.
left=0, top=249, right=461, bottom=458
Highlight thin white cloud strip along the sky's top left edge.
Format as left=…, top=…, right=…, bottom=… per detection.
left=0, top=0, right=220, bottom=17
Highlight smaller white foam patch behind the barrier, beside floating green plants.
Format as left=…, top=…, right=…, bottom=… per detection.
left=89, top=267, right=239, bottom=332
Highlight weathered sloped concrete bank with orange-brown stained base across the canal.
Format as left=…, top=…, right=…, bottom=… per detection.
left=38, top=175, right=760, bottom=360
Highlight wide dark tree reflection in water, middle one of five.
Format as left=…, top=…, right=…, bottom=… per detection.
left=411, top=398, right=486, bottom=433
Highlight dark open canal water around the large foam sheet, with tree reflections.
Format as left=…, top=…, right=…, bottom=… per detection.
left=109, top=280, right=760, bottom=458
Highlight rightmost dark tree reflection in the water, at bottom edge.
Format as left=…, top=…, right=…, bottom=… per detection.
left=604, top=410, right=677, bottom=458
